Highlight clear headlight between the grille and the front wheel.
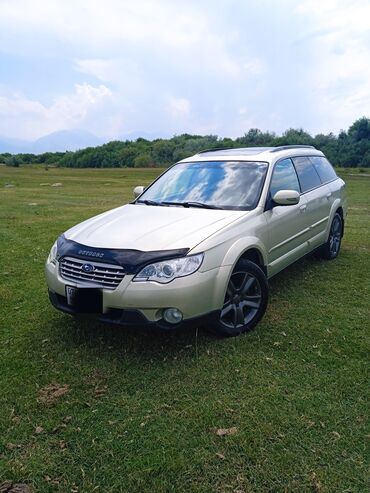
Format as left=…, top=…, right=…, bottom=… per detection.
left=134, top=253, right=204, bottom=284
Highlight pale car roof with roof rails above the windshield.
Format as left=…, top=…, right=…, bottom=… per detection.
left=181, top=145, right=323, bottom=162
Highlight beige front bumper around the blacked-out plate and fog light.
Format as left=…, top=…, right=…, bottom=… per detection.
left=45, top=262, right=228, bottom=329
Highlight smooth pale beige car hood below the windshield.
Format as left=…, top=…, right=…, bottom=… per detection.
left=65, top=204, right=246, bottom=251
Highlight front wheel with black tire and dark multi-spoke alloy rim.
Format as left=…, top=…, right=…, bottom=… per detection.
left=214, top=259, right=268, bottom=337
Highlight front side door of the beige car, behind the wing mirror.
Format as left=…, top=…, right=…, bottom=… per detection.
left=264, top=159, right=310, bottom=276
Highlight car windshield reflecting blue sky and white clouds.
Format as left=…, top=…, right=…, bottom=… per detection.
left=137, top=161, right=268, bottom=210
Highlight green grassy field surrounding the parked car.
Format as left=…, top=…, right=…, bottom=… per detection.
left=0, top=167, right=370, bottom=493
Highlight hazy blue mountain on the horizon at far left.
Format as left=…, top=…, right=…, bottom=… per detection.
left=0, top=129, right=104, bottom=154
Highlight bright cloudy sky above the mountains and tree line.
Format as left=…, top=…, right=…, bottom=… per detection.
left=0, top=0, right=370, bottom=139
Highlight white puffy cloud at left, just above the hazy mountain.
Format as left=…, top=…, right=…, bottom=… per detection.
left=0, top=83, right=112, bottom=139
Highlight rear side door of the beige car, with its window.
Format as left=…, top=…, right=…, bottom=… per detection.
left=293, top=156, right=332, bottom=250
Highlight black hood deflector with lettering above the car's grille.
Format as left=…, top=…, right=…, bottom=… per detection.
left=57, top=235, right=189, bottom=274
